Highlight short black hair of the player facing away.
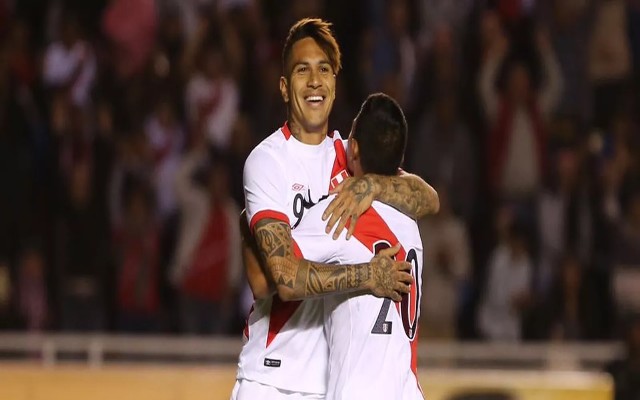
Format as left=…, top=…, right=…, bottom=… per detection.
left=352, top=93, right=407, bottom=175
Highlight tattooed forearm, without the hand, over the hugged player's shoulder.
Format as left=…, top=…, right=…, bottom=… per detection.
left=375, top=175, right=437, bottom=218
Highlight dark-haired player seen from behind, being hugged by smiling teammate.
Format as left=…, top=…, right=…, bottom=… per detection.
left=293, top=93, right=423, bottom=400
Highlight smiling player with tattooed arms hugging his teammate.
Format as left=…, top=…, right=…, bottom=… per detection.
left=232, top=19, right=438, bottom=400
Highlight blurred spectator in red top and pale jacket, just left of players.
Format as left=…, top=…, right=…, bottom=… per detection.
left=170, top=144, right=242, bottom=334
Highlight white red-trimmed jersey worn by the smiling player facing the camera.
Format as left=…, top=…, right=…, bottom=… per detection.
left=237, top=124, right=348, bottom=394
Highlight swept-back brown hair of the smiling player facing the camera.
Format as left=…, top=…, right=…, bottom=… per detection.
left=282, top=18, right=342, bottom=76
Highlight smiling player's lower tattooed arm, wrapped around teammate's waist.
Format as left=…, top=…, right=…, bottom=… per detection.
left=254, top=218, right=412, bottom=301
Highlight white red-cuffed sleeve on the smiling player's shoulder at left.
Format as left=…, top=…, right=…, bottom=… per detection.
left=243, top=149, right=289, bottom=230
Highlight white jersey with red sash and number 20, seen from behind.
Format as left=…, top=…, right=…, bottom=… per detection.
left=293, top=199, right=423, bottom=400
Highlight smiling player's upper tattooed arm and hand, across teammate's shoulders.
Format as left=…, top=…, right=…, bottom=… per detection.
left=322, top=171, right=440, bottom=239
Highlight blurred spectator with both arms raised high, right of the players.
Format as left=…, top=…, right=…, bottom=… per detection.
left=478, top=23, right=562, bottom=201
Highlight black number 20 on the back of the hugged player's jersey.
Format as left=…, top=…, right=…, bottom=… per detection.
left=371, top=241, right=420, bottom=340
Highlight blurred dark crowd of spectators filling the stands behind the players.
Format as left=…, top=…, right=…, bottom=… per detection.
left=0, top=0, right=640, bottom=341
